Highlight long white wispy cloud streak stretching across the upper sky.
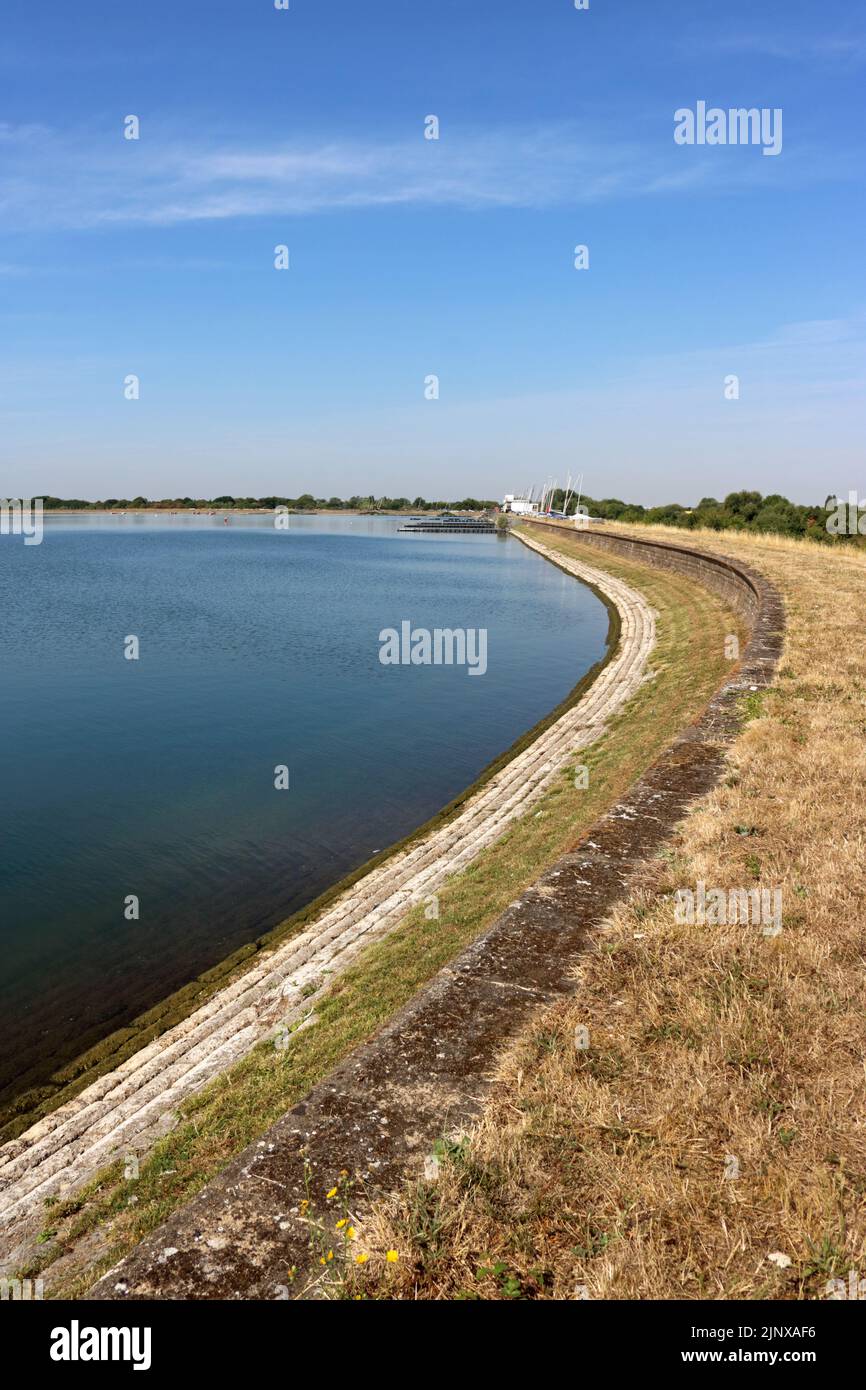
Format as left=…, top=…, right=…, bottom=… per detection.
left=0, top=119, right=842, bottom=228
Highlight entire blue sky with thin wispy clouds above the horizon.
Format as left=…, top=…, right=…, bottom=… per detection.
left=0, top=0, right=866, bottom=502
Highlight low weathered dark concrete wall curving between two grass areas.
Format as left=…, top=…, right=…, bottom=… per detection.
left=89, top=535, right=784, bottom=1298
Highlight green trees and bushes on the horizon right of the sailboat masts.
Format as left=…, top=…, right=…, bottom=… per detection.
left=552, top=489, right=848, bottom=542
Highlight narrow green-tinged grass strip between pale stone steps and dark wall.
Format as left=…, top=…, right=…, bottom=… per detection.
left=28, top=538, right=740, bottom=1294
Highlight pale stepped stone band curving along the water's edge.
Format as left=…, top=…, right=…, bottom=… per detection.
left=0, top=535, right=655, bottom=1225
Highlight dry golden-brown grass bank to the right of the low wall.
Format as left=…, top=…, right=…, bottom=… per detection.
left=352, top=528, right=866, bottom=1298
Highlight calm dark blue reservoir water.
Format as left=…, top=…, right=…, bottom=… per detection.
left=0, top=516, right=607, bottom=1098
